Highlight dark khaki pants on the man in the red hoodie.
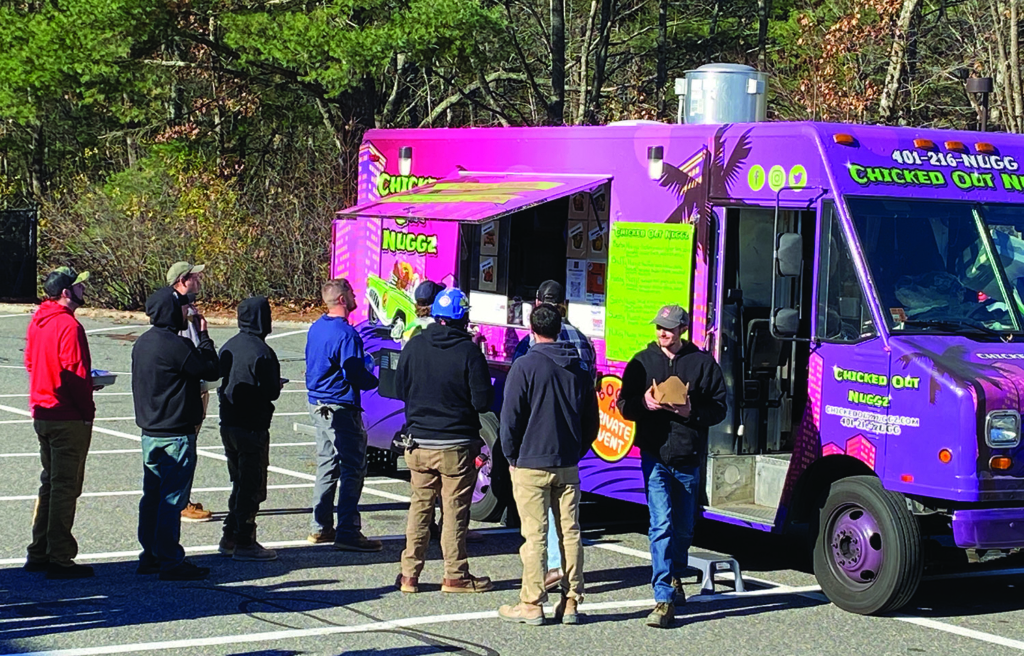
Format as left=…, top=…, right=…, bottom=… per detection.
left=28, top=420, right=92, bottom=566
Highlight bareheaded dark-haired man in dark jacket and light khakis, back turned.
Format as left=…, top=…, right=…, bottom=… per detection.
left=498, top=303, right=600, bottom=624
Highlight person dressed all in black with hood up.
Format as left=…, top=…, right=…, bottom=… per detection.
left=217, top=296, right=283, bottom=561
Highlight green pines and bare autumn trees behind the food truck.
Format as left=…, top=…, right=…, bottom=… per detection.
left=0, top=0, right=1011, bottom=309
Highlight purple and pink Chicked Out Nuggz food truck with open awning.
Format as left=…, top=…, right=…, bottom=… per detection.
left=331, top=63, right=1024, bottom=614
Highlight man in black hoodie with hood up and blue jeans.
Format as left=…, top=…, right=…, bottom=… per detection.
left=131, top=288, right=220, bottom=580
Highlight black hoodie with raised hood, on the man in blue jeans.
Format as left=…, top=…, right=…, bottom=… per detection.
left=131, top=287, right=220, bottom=437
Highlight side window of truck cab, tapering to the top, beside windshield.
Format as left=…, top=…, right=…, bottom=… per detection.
left=817, top=203, right=877, bottom=342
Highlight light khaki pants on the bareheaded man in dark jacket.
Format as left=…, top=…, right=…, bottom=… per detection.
left=512, top=467, right=583, bottom=604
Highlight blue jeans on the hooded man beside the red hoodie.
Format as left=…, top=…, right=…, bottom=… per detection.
left=138, top=435, right=196, bottom=571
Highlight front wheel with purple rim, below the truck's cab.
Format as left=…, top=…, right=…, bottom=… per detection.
left=814, top=476, right=925, bottom=615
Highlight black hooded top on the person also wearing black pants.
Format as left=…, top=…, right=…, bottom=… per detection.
left=217, top=296, right=281, bottom=431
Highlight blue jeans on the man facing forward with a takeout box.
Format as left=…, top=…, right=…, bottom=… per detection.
left=640, top=451, right=700, bottom=604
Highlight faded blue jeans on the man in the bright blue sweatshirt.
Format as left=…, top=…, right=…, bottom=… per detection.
left=309, top=403, right=367, bottom=542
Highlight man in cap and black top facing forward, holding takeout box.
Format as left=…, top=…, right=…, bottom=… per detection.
left=618, top=305, right=726, bottom=628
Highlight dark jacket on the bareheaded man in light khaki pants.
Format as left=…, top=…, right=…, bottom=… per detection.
left=502, top=342, right=600, bottom=469
